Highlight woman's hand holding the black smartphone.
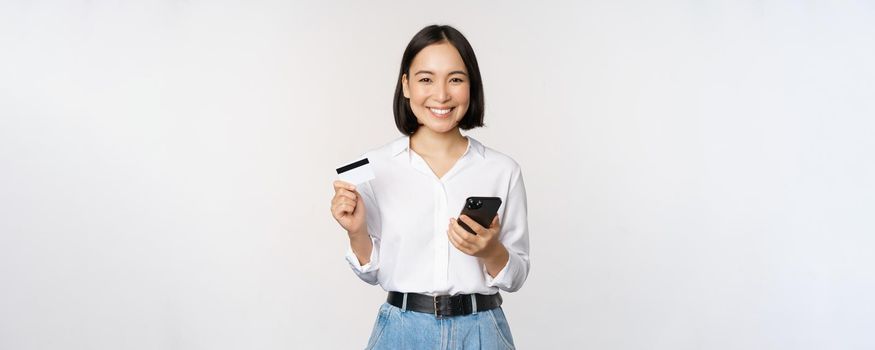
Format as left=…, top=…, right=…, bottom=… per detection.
left=447, top=215, right=507, bottom=259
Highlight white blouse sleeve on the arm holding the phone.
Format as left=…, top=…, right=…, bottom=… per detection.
left=483, top=168, right=530, bottom=292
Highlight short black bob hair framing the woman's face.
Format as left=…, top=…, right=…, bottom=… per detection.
left=392, top=25, right=485, bottom=135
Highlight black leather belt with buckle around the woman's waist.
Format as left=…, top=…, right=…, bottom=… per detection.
left=386, top=292, right=501, bottom=318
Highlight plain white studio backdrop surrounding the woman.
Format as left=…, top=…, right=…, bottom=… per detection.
left=0, top=0, right=875, bottom=350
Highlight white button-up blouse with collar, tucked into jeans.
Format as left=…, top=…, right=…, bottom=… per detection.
left=346, top=137, right=529, bottom=295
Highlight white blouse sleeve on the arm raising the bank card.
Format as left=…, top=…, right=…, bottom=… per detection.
left=346, top=182, right=382, bottom=285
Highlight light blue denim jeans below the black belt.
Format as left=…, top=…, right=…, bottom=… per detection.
left=367, top=303, right=514, bottom=350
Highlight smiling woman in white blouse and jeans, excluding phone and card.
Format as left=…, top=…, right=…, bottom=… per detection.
left=331, top=25, right=530, bottom=349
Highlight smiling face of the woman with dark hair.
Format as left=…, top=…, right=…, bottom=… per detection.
left=401, top=42, right=471, bottom=133
